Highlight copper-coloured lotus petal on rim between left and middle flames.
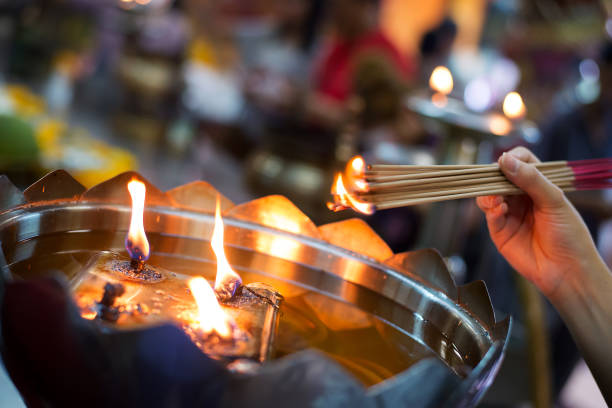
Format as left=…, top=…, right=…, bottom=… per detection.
left=166, top=181, right=235, bottom=212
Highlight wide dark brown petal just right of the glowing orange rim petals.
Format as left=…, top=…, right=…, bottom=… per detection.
left=385, top=248, right=457, bottom=300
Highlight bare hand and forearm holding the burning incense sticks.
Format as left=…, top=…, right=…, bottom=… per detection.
left=476, top=147, right=612, bottom=404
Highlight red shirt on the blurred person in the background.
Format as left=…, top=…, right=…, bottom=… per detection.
left=315, top=31, right=414, bottom=102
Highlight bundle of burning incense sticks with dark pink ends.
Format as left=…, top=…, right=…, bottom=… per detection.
left=328, top=156, right=612, bottom=214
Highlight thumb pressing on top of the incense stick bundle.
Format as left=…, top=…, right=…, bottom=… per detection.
left=499, top=153, right=564, bottom=208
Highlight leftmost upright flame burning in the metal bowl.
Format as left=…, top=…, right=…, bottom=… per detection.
left=125, top=180, right=149, bottom=262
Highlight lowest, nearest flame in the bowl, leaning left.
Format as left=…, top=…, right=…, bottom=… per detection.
left=188, top=276, right=233, bottom=338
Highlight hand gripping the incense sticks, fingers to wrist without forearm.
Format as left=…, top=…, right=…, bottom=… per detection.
left=476, top=147, right=600, bottom=301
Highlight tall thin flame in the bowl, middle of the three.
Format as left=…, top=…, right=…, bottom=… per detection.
left=210, top=196, right=242, bottom=298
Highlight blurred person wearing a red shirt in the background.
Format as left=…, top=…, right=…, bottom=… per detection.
left=249, top=0, right=414, bottom=129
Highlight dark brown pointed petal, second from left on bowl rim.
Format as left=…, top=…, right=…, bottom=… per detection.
left=23, top=170, right=85, bottom=203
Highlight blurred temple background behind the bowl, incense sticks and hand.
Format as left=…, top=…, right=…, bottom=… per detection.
left=0, top=0, right=612, bottom=407
